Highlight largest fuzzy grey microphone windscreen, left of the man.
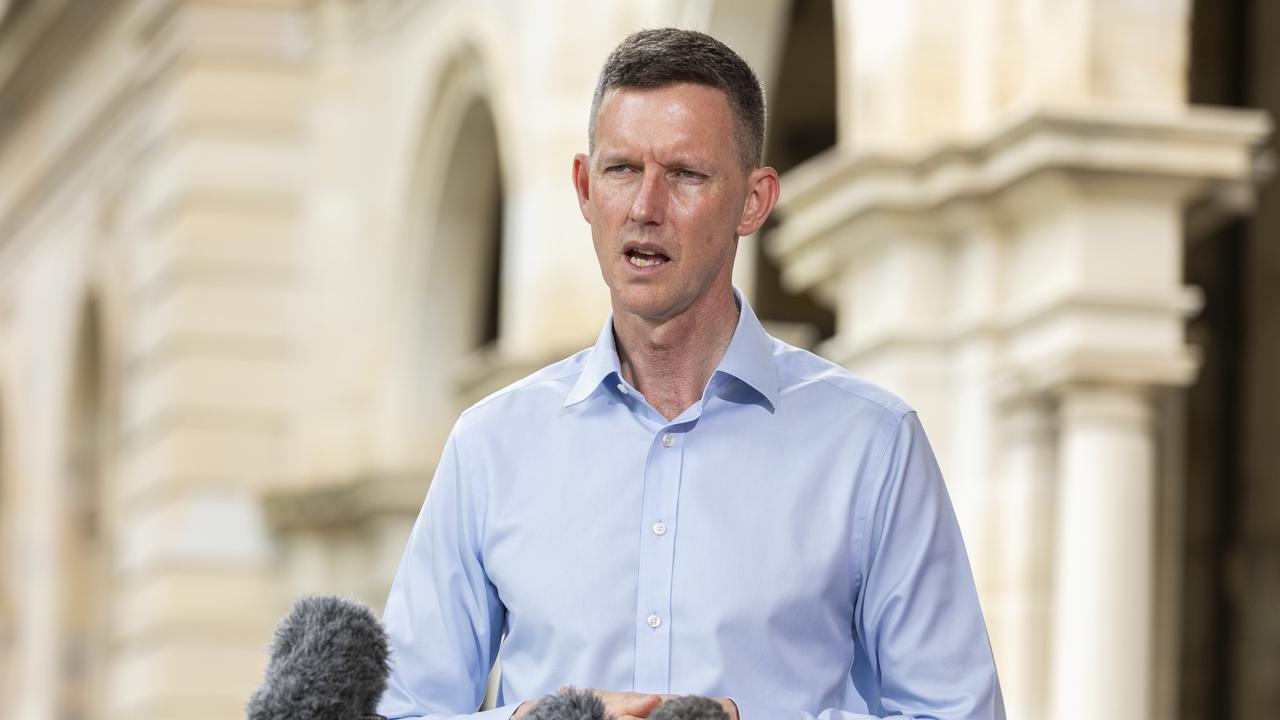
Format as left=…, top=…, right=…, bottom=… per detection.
left=244, top=596, right=388, bottom=720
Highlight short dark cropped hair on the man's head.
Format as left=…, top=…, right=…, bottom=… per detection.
left=588, top=27, right=764, bottom=168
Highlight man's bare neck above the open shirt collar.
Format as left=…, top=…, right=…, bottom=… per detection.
left=613, top=290, right=739, bottom=420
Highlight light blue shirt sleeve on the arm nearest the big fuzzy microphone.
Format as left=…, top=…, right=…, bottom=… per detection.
left=378, top=428, right=516, bottom=720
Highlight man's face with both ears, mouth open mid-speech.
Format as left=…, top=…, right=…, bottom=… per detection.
left=573, top=83, right=777, bottom=322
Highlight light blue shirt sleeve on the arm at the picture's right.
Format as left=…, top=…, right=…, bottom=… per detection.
left=735, top=413, right=1005, bottom=720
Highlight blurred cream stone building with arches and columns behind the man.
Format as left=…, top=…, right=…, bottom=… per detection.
left=0, top=0, right=1280, bottom=720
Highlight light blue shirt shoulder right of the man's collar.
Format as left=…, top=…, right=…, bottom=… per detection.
left=771, top=338, right=915, bottom=425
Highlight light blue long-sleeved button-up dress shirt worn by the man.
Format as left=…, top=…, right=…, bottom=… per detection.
left=379, top=289, right=1005, bottom=720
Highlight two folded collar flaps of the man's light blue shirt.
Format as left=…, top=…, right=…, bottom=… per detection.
left=564, top=288, right=778, bottom=411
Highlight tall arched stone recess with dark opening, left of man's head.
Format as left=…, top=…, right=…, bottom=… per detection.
left=388, top=45, right=506, bottom=459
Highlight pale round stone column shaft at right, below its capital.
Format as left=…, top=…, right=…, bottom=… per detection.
left=1050, top=384, right=1156, bottom=720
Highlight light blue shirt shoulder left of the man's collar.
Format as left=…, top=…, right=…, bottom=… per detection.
left=456, top=348, right=591, bottom=432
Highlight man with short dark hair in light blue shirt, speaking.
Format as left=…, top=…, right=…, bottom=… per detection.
left=380, top=29, right=1004, bottom=720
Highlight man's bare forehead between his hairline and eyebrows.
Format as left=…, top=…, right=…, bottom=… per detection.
left=595, top=83, right=735, bottom=155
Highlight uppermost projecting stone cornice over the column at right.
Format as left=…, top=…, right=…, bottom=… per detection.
left=767, top=106, right=1271, bottom=295
